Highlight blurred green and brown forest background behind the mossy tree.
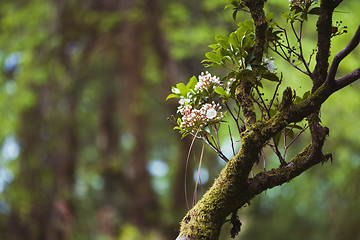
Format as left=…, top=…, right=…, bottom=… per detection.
left=0, top=0, right=360, bottom=240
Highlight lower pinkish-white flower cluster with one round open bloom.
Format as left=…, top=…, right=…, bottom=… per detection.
left=179, top=102, right=224, bottom=132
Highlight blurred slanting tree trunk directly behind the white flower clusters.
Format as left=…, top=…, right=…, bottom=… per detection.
left=146, top=0, right=194, bottom=238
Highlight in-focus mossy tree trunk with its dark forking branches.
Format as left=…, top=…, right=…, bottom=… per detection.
left=177, top=0, right=360, bottom=240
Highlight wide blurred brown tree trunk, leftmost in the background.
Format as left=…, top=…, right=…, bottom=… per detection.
left=5, top=1, right=79, bottom=240
